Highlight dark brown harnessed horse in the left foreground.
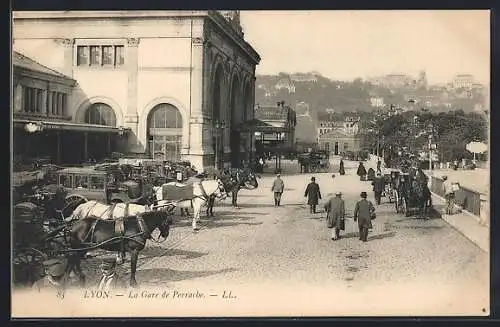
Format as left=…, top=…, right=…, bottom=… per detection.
left=67, top=207, right=174, bottom=287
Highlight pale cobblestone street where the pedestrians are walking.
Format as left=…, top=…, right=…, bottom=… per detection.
left=112, top=163, right=489, bottom=315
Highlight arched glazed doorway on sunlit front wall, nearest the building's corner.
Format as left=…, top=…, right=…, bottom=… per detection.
left=147, top=103, right=182, bottom=161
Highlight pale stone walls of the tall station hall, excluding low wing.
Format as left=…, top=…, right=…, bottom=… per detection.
left=13, top=11, right=260, bottom=172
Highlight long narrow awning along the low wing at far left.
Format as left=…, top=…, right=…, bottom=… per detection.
left=14, top=119, right=130, bottom=134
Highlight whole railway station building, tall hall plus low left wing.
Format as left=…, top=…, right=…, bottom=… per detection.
left=12, top=11, right=260, bottom=169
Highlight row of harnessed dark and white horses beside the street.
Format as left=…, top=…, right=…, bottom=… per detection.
left=59, top=169, right=258, bottom=286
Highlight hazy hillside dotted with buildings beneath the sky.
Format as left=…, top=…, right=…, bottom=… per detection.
left=255, top=72, right=484, bottom=117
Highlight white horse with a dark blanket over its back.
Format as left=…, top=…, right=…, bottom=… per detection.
left=153, top=179, right=226, bottom=231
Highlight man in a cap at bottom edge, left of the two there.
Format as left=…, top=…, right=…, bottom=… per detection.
left=33, top=258, right=68, bottom=292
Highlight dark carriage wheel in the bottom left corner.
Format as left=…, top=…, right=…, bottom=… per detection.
left=12, top=248, right=47, bottom=286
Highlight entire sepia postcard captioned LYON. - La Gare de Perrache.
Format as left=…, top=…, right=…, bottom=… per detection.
left=11, top=10, right=490, bottom=318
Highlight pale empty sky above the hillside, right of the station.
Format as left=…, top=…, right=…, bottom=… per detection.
left=240, top=10, right=490, bottom=85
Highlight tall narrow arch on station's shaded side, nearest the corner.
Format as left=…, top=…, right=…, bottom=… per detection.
left=212, top=66, right=225, bottom=168
